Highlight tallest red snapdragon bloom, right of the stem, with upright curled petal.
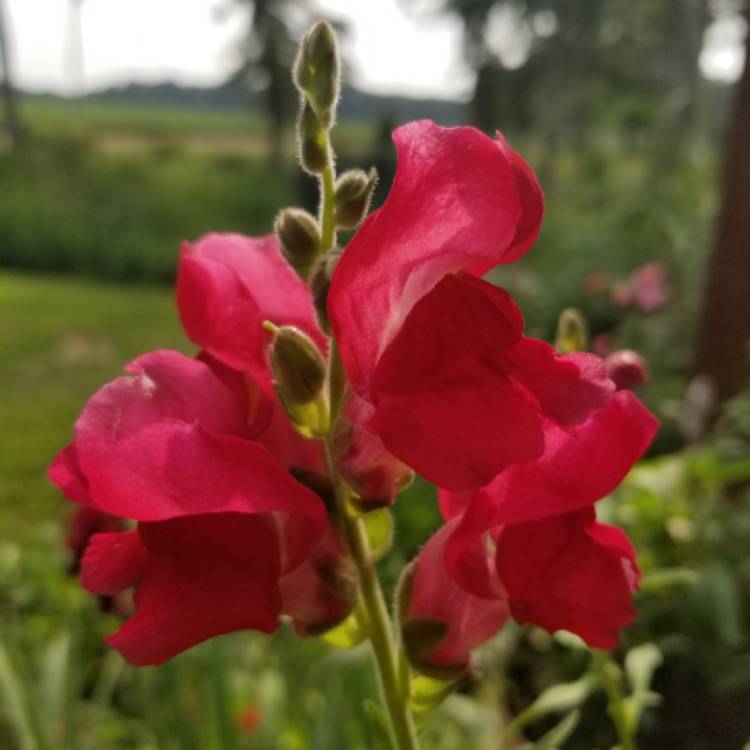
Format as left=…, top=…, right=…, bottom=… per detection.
left=328, top=121, right=613, bottom=490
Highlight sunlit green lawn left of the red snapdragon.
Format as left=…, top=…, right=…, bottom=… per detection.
left=0, top=272, right=190, bottom=536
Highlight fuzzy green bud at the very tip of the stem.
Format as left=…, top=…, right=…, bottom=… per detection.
left=293, top=21, right=341, bottom=129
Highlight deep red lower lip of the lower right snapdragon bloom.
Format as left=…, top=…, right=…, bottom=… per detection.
left=497, top=509, right=639, bottom=648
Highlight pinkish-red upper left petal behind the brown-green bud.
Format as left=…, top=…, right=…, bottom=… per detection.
left=177, top=234, right=327, bottom=393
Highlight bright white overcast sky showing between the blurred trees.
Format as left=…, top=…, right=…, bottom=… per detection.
left=0, top=0, right=744, bottom=98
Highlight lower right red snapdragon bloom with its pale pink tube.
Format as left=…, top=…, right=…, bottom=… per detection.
left=409, top=391, right=657, bottom=665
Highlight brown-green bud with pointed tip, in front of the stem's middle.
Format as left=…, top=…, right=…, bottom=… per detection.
left=263, top=321, right=326, bottom=406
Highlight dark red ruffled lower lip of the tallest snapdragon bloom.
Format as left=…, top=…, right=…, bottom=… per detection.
left=369, top=274, right=613, bottom=490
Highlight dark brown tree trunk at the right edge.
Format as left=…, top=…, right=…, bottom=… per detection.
left=695, top=14, right=750, bottom=424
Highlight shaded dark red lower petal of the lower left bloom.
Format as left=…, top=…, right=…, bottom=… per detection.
left=101, top=514, right=281, bottom=666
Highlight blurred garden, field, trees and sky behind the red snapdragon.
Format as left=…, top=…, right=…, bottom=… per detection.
left=0, top=0, right=750, bottom=750
